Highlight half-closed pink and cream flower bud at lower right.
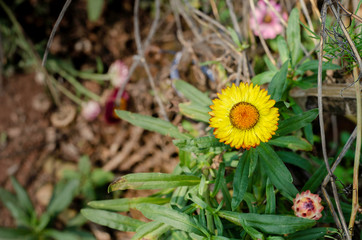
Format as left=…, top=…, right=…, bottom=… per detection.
left=292, top=190, right=324, bottom=220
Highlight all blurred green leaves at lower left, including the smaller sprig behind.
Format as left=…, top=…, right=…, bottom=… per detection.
left=0, top=156, right=114, bottom=240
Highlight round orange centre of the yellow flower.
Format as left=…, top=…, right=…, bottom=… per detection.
left=229, top=102, right=259, bottom=130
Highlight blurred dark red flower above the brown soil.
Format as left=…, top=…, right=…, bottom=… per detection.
left=104, top=88, right=129, bottom=123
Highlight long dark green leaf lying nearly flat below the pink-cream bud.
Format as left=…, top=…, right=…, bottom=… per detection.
left=218, top=211, right=316, bottom=235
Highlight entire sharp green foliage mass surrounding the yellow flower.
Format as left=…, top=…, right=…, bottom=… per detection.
left=82, top=9, right=348, bottom=240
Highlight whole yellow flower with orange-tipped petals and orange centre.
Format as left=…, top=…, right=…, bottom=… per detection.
left=209, top=83, right=279, bottom=149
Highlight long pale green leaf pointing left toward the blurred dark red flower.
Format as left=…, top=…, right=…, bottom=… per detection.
left=115, top=110, right=190, bottom=139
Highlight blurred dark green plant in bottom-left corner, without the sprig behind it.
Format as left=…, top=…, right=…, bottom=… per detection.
left=0, top=177, right=95, bottom=240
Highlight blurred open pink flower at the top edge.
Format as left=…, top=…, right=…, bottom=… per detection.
left=250, top=0, right=288, bottom=39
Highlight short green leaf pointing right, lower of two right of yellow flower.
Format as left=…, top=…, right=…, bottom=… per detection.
left=268, top=136, right=313, bottom=151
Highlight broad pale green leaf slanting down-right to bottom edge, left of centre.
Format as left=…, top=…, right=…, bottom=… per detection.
left=137, top=203, right=210, bottom=236
